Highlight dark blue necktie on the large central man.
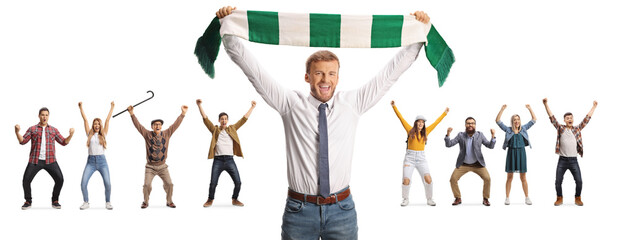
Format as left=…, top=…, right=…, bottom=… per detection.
left=318, top=103, right=331, bottom=198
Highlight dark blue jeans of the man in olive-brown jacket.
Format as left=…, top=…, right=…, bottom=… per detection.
left=208, top=155, right=241, bottom=199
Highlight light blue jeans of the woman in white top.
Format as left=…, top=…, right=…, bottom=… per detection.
left=82, top=155, right=112, bottom=202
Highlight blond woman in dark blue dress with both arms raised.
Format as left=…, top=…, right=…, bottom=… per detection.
left=496, top=104, right=537, bottom=205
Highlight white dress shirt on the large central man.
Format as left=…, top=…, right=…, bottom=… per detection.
left=223, top=35, right=422, bottom=195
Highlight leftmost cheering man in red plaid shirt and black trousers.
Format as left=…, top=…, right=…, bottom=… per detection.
left=15, top=108, right=74, bottom=210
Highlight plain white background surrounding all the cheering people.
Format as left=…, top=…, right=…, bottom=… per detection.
left=0, top=0, right=619, bottom=239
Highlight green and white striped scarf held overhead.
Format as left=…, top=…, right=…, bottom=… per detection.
left=194, top=10, right=455, bottom=86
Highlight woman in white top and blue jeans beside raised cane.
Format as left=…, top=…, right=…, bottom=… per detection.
left=78, top=102, right=114, bottom=210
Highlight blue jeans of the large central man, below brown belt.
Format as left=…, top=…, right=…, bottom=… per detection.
left=282, top=189, right=358, bottom=240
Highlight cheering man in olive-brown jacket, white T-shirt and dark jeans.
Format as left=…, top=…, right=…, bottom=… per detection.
left=196, top=99, right=256, bottom=207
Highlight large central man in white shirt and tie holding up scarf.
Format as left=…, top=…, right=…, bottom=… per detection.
left=216, top=7, right=429, bottom=239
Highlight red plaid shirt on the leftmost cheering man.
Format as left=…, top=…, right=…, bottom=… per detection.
left=20, top=124, right=67, bottom=164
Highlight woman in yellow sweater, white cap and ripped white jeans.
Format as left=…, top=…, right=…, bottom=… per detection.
left=391, top=101, right=449, bottom=207
